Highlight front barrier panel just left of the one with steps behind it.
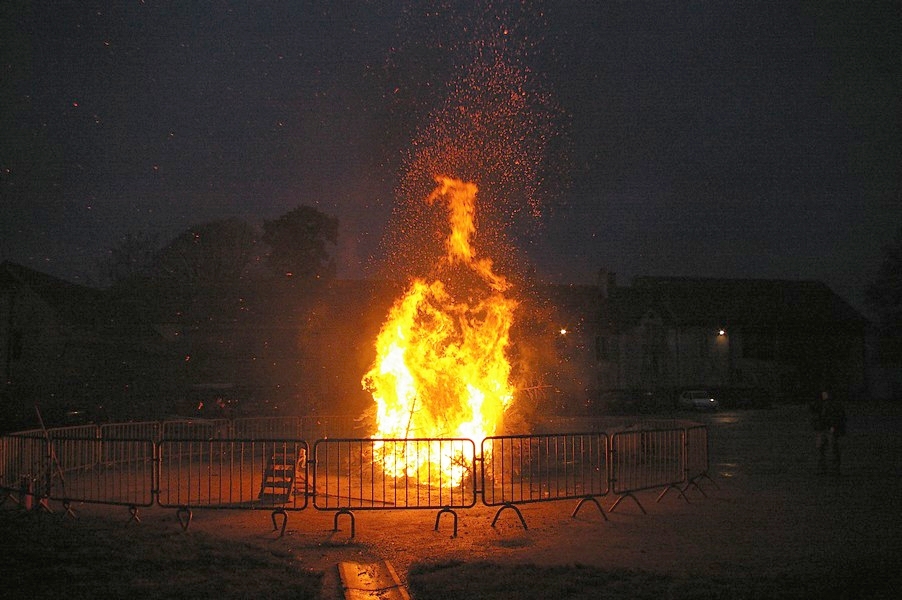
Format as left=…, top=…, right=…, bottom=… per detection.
left=50, top=437, right=155, bottom=516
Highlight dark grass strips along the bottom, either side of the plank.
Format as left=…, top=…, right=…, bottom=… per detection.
left=0, top=510, right=902, bottom=600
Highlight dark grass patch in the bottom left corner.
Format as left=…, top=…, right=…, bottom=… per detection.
left=0, top=510, right=322, bottom=600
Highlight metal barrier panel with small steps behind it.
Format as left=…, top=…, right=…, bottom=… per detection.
left=158, top=439, right=307, bottom=511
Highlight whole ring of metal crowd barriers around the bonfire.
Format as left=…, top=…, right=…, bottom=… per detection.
left=0, top=417, right=710, bottom=537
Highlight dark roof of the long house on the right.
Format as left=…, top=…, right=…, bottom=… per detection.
left=607, top=277, right=867, bottom=330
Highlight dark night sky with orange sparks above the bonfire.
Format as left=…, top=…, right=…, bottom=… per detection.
left=0, top=0, right=902, bottom=308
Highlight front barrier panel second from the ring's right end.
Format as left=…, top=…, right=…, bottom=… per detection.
left=609, top=428, right=686, bottom=513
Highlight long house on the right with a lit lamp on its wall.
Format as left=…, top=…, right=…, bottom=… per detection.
left=595, top=273, right=868, bottom=406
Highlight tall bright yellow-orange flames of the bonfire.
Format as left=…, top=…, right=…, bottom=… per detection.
left=363, top=177, right=516, bottom=483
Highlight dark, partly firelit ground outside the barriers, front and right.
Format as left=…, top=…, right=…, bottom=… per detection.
left=0, top=406, right=902, bottom=600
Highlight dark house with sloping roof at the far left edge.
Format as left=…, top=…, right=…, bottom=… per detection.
left=0, top=261, right=170, bottom=428
